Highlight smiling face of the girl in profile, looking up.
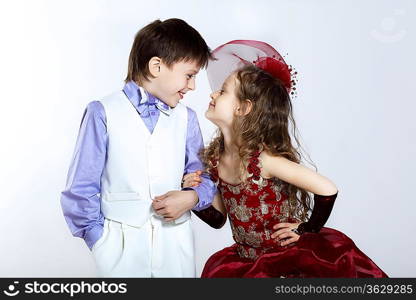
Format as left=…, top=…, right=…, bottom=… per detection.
left=205, top=74, right=240, bottom=127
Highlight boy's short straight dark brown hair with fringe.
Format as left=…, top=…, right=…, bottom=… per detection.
left=125, top=19, right=211, bottom=82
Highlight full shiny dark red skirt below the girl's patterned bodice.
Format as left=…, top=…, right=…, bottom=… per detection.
left=201, top=227, right=388, bottom=278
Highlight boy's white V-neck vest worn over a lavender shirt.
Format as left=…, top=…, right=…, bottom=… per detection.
left=100, top=91, right=191, bottom=227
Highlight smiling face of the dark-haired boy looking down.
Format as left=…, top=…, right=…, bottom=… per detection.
left=152, top=61, right=200, bottom=107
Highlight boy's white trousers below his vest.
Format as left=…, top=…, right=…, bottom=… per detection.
left=92, top=216, right=195, bottom=277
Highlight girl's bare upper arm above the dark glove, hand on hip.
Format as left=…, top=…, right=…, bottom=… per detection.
left=260, top=151, right=337, bottom=195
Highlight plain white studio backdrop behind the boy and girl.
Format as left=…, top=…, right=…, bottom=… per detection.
left=0, top=0, right=416, bottom=277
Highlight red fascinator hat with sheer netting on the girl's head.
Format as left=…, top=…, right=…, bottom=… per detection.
left=207, top=40, right=297, bottom=95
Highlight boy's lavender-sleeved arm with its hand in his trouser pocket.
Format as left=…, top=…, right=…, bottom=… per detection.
left=61, top=101, right=108, bottom=249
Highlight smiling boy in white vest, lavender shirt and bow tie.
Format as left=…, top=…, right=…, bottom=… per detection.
left=61, top=19, right=216, bottom=277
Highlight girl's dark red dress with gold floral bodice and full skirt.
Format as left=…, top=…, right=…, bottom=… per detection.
left=201, top=152, right=387, bottom=278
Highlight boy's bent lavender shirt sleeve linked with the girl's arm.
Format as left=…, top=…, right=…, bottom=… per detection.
left=184, top=107, right=217, bottom=211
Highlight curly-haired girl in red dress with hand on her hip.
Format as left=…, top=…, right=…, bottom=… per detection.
left=184, top=41, right=387, bottom=277
